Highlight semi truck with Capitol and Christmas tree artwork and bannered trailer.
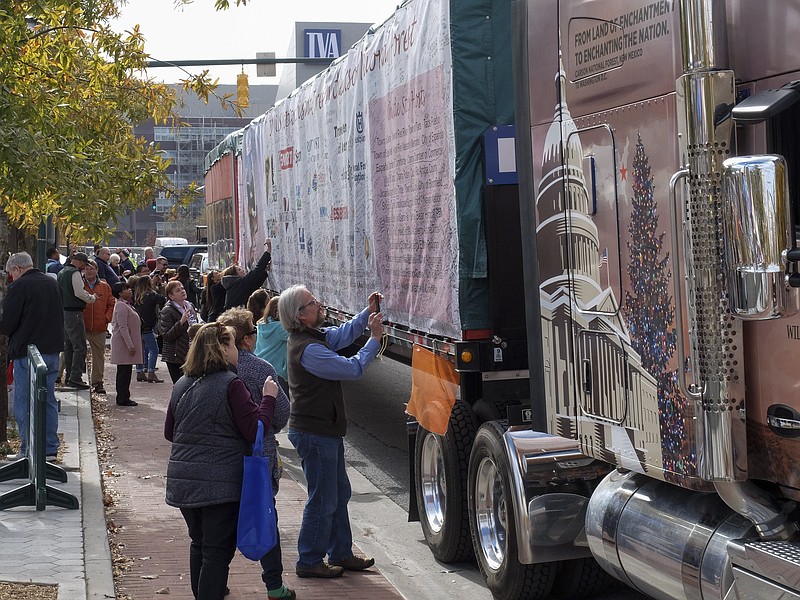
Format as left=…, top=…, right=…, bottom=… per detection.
left=206, top=0, right=800, bottom=600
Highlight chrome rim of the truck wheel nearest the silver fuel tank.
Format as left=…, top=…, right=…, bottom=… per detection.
left=475, top=457, right=507, bottom=571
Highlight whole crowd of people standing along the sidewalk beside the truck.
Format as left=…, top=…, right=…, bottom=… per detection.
left=0, top=245, right=382, bottom=600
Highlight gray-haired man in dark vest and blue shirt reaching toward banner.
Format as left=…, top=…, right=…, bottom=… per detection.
left=278, top=285, right=383, bottom=578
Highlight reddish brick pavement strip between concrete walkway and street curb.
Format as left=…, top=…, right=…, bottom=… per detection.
left=100, top=365, right=402, bottom=600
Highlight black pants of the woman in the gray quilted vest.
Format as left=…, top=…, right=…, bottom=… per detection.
left=181, top=502, right=239, bottom=600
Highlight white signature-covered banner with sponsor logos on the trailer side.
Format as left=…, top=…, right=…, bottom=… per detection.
left=239, top=0, right=460, bottom=338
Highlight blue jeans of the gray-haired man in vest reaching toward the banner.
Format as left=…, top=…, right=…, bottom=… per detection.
left=289, top=429, right=353, bottom=567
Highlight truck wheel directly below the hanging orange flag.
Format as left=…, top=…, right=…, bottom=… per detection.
left=414, top=400, right=475, bottom=563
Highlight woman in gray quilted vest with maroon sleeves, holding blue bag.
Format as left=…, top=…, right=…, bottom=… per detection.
left=164, top=323, right=278, bottom=600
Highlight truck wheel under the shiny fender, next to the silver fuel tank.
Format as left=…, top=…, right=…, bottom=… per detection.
left=467, top=422, right=557, bottom=600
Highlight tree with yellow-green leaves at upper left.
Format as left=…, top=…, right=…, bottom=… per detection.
left=0, top=0, right=227, bottom=445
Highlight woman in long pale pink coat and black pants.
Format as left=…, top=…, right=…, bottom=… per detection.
left=111, top=281, right=143, bottom=406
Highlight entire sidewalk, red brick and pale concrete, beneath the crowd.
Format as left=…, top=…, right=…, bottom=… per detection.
left=0, top=358, right=403, bottom=600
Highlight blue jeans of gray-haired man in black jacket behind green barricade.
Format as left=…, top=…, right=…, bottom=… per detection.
left=14, top=352, right=60, bottom=456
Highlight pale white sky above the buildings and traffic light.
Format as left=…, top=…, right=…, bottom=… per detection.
left=113, top=0, right=401, bottom=85
